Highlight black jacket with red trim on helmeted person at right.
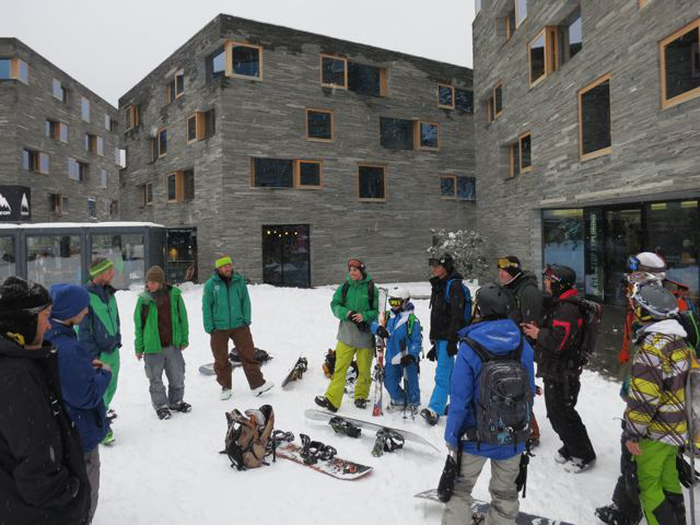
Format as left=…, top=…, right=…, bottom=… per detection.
left=536, top=289, right=584, bottom=381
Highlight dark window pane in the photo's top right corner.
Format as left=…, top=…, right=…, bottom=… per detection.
left=664, top=27, right=700, bottom=99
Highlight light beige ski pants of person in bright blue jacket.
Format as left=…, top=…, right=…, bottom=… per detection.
left=442, top=452, right=520, bottom=525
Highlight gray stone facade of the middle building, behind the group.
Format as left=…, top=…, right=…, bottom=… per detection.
left=119, top=15, right=480, bottom=285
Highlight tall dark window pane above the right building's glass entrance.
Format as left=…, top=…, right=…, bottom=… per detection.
left=581, top=80, right=611, bottom=155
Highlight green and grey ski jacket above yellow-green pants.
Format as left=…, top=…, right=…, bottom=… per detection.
left=331, top=274, right=379, bottom=348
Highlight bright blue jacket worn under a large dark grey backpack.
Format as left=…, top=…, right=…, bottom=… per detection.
left=445, top=319, right=535, bottom=459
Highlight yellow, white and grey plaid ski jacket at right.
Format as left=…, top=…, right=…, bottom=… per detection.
left=625, top=319, right=693, bottom=446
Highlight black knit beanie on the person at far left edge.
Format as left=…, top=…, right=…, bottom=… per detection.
left=0, top=276, right=51, bottom=346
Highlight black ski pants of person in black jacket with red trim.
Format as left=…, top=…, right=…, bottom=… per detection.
left=544, top=375, right=596, bottom=461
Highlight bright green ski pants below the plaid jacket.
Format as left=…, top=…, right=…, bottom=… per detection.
left=634, top=439, right=685, bottom=525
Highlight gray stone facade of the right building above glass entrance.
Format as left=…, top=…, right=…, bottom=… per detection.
left=473, top=0, right=700, bottom=271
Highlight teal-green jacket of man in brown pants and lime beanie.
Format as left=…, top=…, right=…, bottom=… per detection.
left=202, top=272, right=250, bottom=334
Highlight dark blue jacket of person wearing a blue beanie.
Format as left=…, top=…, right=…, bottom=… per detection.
left=45, top=319, right=112, bottom=454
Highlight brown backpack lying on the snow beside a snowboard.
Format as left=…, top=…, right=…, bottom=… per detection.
left=224, top=405, right=275, bottom=470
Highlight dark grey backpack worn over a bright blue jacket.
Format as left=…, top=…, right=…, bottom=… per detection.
left=463, top=336, right=533, bottom=449
